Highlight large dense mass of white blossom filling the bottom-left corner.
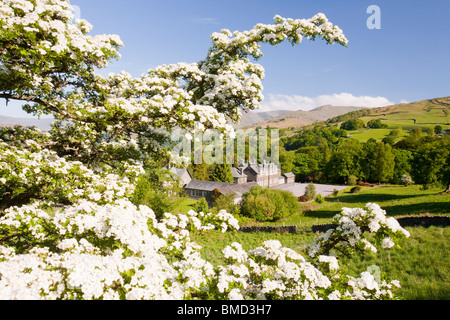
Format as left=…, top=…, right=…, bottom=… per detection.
left=0, top=199, right=243, bottom=299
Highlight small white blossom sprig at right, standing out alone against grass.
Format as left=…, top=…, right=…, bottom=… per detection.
left=308, top=203, right=410, bottom=257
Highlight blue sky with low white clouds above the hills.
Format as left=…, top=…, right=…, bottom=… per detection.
left=0, top=0, right=450, bottom=116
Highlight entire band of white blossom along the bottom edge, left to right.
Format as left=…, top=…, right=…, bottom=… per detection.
left=0, top=199, right=408, bottom=300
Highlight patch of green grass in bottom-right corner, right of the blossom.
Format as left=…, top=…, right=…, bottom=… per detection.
left=342, top=227, right=450, bottom=300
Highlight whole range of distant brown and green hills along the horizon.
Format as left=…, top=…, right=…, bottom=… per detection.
left=0, top=97, right=450, bottom=134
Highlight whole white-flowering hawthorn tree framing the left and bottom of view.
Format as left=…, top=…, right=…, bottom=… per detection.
left=0, top=0, right=407, bottom=299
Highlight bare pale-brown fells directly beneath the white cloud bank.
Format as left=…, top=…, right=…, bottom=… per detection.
left=239, top=105, right=364, bottom=129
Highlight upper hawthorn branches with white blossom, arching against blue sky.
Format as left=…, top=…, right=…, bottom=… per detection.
left=0, top=0, right=347, bottom=169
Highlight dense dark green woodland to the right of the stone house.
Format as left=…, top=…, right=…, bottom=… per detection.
left=280, top=125, right=450, bottom=188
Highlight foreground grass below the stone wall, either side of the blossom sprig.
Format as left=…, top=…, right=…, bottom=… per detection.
left=194, top=227, right=450, bottom=300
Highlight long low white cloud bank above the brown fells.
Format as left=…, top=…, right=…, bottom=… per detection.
left=260, top=92, right=395, bottom=111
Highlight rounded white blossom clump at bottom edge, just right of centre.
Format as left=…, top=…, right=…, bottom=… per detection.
left=214, top=240, right=331, bottom=299
